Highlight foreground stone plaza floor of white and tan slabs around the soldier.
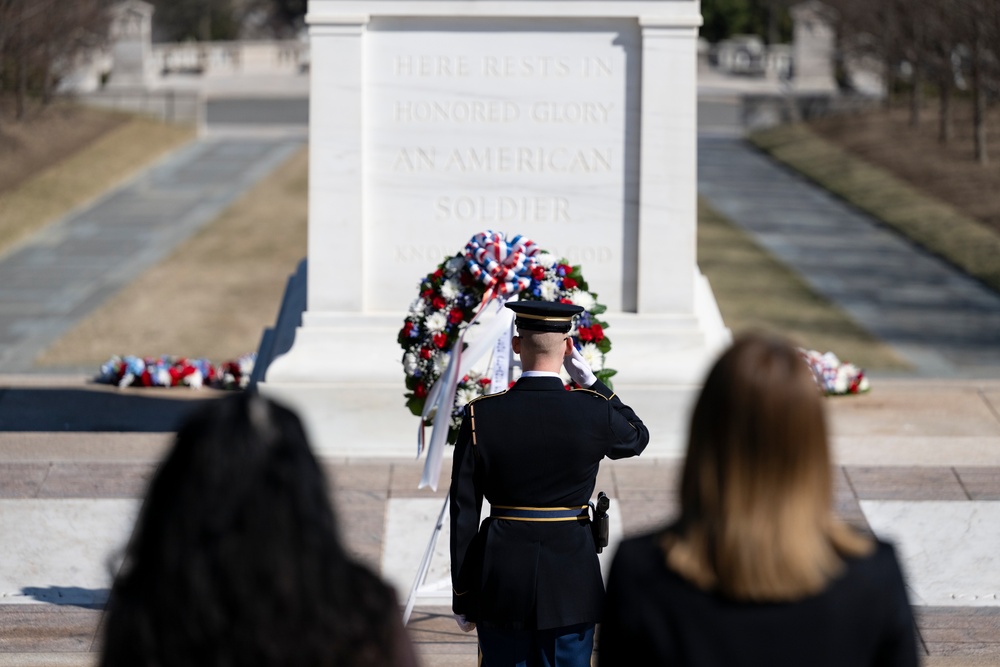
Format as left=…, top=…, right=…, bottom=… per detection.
left=0, top=375, right=1000, bottom=667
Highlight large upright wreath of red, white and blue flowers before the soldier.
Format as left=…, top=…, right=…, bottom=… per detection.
left=397, top=231, right=616, bottom=442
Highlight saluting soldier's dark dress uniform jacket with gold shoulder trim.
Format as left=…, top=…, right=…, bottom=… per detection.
left=451, top=377, right=649, bottom=630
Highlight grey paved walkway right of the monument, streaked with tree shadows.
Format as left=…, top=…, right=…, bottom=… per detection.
left=698, top=135, right=1000, bottom=378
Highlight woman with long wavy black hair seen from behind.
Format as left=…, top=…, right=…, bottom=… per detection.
left=101, top=394, right=416, bottom=667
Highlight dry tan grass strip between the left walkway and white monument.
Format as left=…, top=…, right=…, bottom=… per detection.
left=37, top=148, right=308, bottom=372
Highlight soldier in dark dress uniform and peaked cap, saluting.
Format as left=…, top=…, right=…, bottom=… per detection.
left=451, top=301, right=649, bottom=667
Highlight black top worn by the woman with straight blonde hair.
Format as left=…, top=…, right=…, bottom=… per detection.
left=598, top=533, right=917, bottom=667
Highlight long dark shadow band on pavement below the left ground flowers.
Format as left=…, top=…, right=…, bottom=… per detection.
left=0, top=387, right=225, bottom=433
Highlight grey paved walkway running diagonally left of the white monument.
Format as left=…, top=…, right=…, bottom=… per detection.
left=0, top=136, right=303, bottom=372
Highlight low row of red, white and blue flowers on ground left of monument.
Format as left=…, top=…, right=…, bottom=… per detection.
left=95, top=352, right=257, bottom=389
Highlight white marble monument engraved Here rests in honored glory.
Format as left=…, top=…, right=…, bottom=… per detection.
left=260, top=0, right=728, bottom=454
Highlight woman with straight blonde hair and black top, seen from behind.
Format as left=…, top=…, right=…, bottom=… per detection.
left=598, top=335, right=917, bottom=667
